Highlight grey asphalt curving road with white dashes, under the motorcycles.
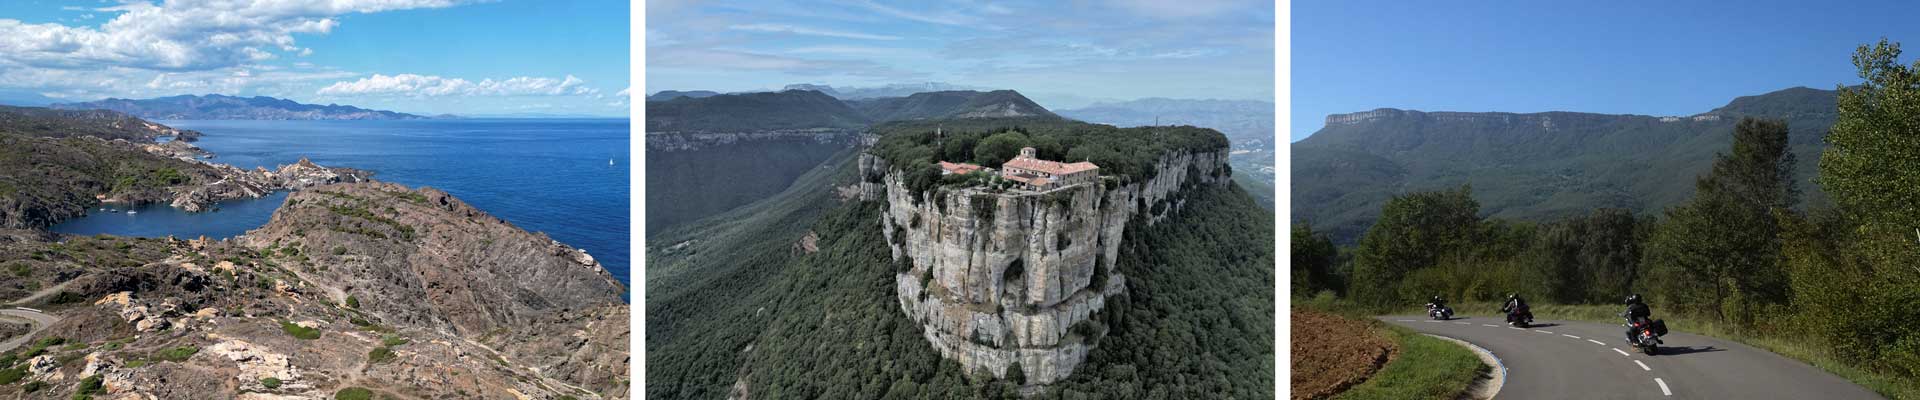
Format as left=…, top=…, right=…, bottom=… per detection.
left=1379, top=315, right=1882, bottom=400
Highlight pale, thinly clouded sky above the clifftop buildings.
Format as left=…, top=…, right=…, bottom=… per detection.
left=645, top=0, right=1273, bottom=108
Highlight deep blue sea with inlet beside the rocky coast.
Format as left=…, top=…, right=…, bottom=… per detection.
left=52, top=119, right=632, bottom=288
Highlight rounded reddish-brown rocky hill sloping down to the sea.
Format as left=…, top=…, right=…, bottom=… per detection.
left=234, top=183, right=628, bottom=396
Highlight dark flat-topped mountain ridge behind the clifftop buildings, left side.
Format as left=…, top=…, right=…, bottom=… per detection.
left=647, top=90, right=1060, bottom=133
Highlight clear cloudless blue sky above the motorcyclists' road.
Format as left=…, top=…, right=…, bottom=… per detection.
left=1290, top=2, right=1920, bottom=140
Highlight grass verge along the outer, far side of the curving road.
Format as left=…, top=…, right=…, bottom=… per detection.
left=1398, top=302, right=1920, bottom=400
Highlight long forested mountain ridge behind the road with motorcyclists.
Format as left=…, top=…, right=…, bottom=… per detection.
left=1292, top=87, right=1837, bottom=242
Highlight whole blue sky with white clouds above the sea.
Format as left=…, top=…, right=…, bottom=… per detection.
left=0, top=0, right=632, bottom=115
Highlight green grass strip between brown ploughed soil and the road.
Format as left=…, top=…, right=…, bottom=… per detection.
left=1334, top=323, right=1492, bottom=400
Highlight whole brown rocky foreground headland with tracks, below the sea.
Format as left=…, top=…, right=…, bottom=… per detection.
left=0, top=183, right=630, bottom=400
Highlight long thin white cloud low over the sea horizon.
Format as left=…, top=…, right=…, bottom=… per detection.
left=319, top=73, right=599, bottom=96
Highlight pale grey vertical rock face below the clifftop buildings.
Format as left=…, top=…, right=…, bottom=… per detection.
left=860, top=150, right=1231, bottom=385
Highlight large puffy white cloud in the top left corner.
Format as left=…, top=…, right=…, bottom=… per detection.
left=0, top=0, right=468, bottom=71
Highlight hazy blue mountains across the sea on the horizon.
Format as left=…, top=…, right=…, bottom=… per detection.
left=52, top=94, right=426, bottom=119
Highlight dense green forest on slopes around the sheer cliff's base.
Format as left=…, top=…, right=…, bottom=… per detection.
left=645, top=119, right=1275, bottom=398
